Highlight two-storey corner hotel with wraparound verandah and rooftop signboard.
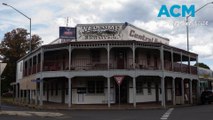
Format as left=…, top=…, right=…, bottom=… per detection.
left=16, top=23, right=199, bottom=107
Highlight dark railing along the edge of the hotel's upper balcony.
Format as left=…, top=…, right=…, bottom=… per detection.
left=23, top=61, right=197, bottom=76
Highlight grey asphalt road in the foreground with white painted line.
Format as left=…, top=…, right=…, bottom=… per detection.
left=0, top=104, right=213, bottom=120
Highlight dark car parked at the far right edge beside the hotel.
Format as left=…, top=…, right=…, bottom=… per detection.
left=201, top=90, right=213, bottom=104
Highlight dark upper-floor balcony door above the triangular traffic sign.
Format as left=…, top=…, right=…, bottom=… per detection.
left=116, top=50, right=125, bottom=69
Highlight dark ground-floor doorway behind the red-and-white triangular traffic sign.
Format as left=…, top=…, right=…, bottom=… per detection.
left=115, top=79, right=129, bottom=104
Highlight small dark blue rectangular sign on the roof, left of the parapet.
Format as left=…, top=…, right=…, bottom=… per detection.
left=59, top=27, right=76, bottom=39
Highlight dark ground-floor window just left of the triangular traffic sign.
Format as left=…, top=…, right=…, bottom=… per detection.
left=88, top=80, right=104, bottom=94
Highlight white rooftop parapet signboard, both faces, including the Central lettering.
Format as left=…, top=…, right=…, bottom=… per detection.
left=76, top=23, right=169, bottom=44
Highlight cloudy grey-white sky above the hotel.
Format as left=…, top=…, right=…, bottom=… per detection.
left=0, top=0, right=213, bottom=69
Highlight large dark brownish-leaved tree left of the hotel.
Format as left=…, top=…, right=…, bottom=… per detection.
left=0, top=28, right=42, bottom=93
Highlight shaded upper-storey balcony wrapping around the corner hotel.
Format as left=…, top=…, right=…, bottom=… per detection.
left=23, top=47, right=197, bottom=76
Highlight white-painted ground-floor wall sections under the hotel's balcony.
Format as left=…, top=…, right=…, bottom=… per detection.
left=39, top=81, right=172, bottom=104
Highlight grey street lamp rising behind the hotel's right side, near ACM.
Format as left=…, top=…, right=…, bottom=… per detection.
left=186, top=2, right=213, bottom=52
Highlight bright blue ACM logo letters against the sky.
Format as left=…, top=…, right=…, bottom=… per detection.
left=158, top=5, right=195, bottom=17
